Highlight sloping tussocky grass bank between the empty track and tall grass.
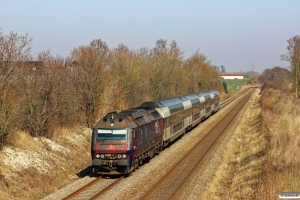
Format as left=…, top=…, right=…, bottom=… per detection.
left=202, top=88, right=265, bottom=199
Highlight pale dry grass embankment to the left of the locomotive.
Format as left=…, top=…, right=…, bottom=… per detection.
left=0, top=128, right=91, bottom=200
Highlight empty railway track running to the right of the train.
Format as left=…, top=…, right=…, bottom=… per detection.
left=141, top=88, right=255, bottom=199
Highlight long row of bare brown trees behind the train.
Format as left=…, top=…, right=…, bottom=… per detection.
left=0, top=29, right=223, bottom=145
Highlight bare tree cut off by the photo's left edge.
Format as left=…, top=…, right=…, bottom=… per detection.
left=0, top=29, right=32, bottom=144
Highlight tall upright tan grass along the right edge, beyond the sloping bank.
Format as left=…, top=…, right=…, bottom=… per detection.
left=260, top=89, right=300, bottom=199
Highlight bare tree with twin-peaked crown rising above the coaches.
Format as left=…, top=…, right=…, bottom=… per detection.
left=147, top=39, right=186, bottom=99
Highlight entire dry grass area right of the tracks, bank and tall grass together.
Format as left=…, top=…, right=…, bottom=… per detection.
left=203, top=89, right=300, bottom=200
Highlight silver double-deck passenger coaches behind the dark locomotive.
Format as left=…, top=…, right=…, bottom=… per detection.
left=140, top=90, right=220, bottom=146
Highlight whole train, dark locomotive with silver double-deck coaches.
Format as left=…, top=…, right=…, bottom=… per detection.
left=91, top=89, right=220, bottom=175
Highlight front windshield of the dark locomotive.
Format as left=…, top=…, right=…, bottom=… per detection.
left=97, top=128, right=126, bottom=141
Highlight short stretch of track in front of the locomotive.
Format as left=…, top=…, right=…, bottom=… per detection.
left=63, top=176, right=124, bottom=200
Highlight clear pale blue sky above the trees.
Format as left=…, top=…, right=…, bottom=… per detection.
left=0, top=0, right=300, bottom=73
